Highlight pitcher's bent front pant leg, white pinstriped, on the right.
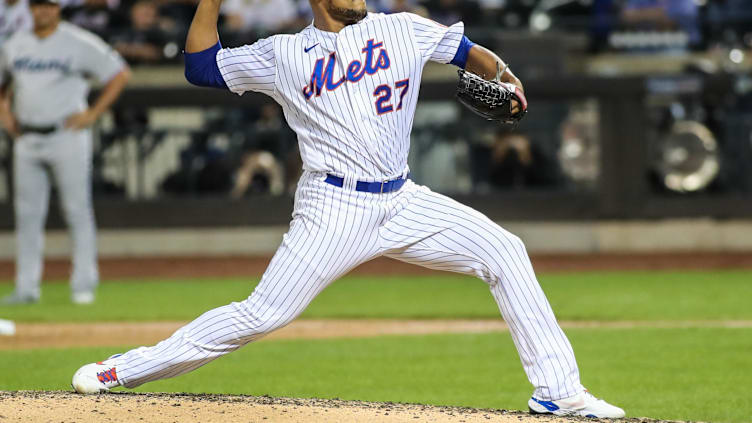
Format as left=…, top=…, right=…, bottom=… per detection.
left=379, top=183, right=584, bottom=399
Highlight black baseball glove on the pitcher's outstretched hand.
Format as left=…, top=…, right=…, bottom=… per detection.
left=457, top=63, right=527, bottom=125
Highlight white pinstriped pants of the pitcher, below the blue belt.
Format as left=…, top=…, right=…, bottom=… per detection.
left=116, top=172, right=583, bottom=400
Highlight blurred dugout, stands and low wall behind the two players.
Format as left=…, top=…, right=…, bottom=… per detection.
left=0, top=0, right=752, bottom=268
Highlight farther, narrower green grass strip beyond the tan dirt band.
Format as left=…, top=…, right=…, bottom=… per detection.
left=0, top=271, right=752, bottom=322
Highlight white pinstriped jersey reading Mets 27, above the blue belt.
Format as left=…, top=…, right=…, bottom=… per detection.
left=217, top=13, right=464, bottom=181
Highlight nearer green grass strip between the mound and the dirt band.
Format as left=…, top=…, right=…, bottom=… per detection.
left=0, top=329, right=752, bottom=423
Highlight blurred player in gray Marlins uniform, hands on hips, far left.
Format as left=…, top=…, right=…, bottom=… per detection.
left=0, top=0, right=130, bottom=304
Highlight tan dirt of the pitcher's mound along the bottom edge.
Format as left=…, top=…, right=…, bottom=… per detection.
left=0, top=391, right=676, bottom=423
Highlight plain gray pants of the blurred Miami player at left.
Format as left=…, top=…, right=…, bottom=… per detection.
left=13, top=129, right=99, bottom=298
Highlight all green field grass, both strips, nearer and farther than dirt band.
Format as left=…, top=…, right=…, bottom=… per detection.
left=0, top=271, right=752, bottom=423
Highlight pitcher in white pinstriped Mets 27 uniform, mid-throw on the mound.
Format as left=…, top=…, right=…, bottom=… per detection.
left=73, top=0, right=624, bottom=417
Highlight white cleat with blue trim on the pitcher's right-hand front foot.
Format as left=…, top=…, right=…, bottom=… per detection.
left=527, top=390, right=624, bottom=419
